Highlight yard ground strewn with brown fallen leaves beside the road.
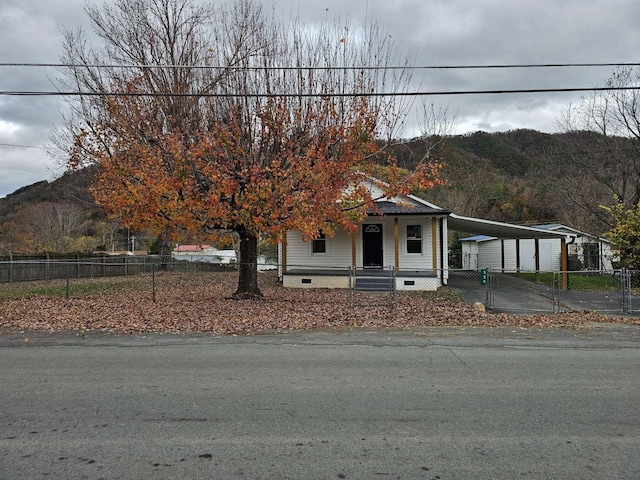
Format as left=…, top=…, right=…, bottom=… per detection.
left=0, top=272, right=640, bottom=334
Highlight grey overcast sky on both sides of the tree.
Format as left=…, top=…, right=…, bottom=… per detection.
left=0, top=0, right=640, bottom=197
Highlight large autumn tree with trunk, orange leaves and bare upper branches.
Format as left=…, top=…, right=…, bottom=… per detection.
left=58, top=0, right=439, bottom=298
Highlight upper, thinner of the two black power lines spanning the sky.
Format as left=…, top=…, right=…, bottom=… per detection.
left=0, top=62, right=640, bottom=71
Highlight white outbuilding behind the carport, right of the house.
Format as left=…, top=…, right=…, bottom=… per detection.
left=459, top=224, right=614, bottom=272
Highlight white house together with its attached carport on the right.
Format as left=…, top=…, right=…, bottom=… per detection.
left=278, top=178, right=592, bottom=290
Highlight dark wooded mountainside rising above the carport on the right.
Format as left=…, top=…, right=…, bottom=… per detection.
left=410, top=130, right=637, bottom=234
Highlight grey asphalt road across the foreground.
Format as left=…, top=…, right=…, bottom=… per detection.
left=0, top=326, right=640, bottom=480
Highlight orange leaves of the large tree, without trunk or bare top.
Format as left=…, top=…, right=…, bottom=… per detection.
left=81, top=82, right=441, bottom=244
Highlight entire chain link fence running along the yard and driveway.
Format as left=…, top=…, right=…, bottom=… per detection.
left=0, top=256, right=640, bottom=315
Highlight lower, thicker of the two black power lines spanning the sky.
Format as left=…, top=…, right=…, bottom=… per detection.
left=0, top=86, right=640, bottom=98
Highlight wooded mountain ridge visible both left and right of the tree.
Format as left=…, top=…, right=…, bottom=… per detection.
left=0, top=130, right=635, bottom=251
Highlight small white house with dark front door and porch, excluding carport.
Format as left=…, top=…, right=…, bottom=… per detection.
left=278, top=187, right=449, bottom=290
